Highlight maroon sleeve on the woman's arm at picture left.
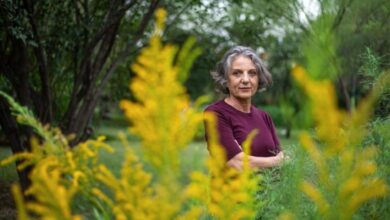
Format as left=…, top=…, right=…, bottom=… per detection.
left=204, top=110, right=242, bottom=161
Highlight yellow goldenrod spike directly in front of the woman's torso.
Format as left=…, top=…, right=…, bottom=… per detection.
left=186, top=113, right=257, bottom=219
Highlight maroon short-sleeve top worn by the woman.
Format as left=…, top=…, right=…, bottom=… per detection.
left=205, top=100, right=281, bottom=160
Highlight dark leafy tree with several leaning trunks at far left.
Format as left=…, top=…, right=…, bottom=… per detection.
left=0, top=0, right=204, bottom=189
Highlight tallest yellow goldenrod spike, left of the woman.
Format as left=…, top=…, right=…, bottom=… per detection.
left=120, top=9, right=202, bottom=174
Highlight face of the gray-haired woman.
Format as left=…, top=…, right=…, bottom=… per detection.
left=227, top=56, right=259, bottom=100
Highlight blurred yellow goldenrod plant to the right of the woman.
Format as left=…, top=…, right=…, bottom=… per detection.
left=292, top=66, right=390, bottom=219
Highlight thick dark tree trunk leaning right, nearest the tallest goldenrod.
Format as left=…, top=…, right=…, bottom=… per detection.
left=61, top=0, right=160, bottom=146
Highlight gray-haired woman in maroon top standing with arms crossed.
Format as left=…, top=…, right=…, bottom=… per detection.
left=205, top=46, right=284, bottom=170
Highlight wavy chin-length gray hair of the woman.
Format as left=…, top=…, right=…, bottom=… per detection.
left=211, top=46, right=272, bottom=94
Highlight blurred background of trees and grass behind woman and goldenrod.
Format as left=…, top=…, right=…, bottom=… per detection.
left=0, top=0, right=390, bottom=217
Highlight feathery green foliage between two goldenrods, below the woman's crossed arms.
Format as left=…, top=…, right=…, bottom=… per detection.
left=256, top=145, right=315, bottom=219
